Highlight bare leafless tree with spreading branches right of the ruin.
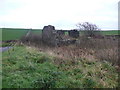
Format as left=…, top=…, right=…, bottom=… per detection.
left=76, top=22, right=100, bottom=37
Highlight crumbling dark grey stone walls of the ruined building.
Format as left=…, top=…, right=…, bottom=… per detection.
left=42, top=25, right=79, bottom=46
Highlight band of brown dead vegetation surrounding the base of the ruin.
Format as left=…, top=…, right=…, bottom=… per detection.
left=21, top=34, right=119, bottom=65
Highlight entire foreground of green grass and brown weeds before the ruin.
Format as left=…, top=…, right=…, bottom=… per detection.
left=2, top=33, right=118, bottom=88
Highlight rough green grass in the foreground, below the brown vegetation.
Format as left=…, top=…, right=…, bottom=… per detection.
left=2, top=46, right=118, bottom=88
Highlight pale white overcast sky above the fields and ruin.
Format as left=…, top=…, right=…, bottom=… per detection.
left=0, top=0, right=119, bottom=30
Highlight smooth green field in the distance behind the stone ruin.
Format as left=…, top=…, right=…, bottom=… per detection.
left=0, top=28, right=120, bottom=41
